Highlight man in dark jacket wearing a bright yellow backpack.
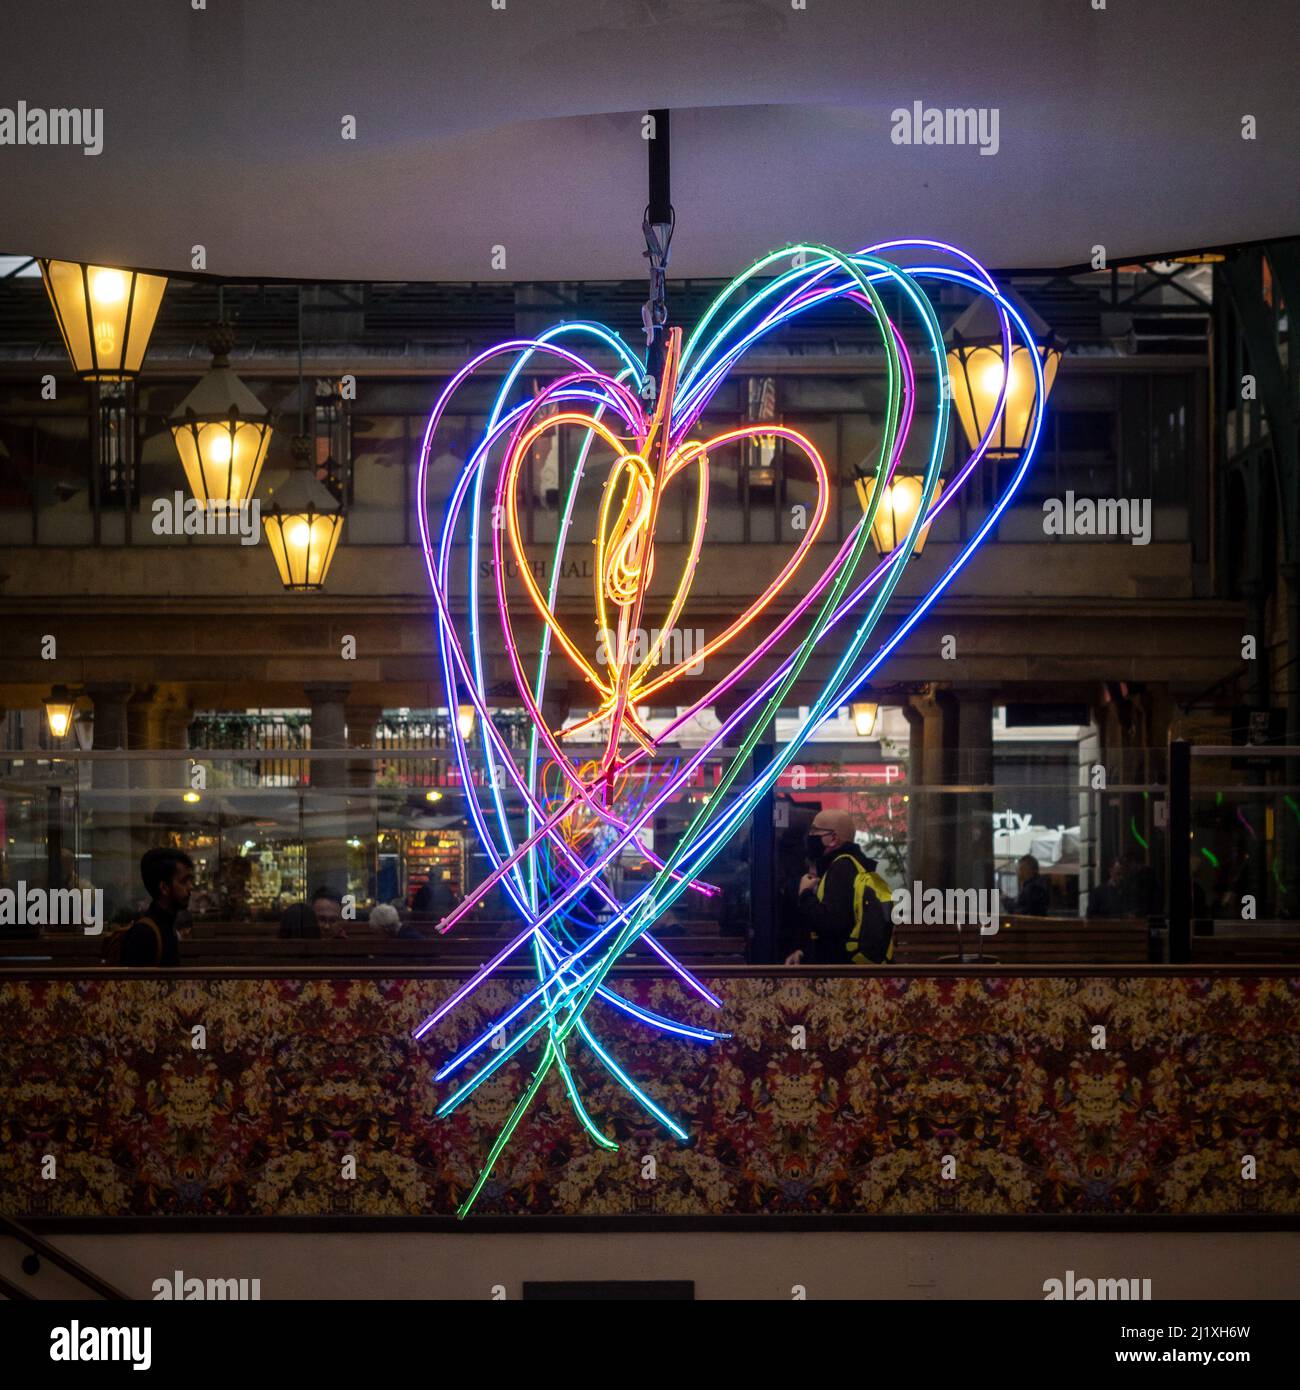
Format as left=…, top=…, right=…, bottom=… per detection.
left=786, top=810, right=894, bottom=965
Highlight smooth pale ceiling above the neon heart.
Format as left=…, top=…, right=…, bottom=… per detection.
left=0, top=0, right=1300, bottom=279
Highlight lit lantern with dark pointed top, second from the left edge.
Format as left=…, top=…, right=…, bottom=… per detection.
left=171, top=324, right=271, bottom=506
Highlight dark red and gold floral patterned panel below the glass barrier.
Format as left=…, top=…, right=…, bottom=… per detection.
left=0, top=973, right=1300, bottom=1218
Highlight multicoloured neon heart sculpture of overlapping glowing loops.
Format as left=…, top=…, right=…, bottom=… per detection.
left=414, top=240, right=1046, bottom=1216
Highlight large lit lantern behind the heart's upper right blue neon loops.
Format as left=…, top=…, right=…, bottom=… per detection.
left=948, top=295, right=1062, bottom=459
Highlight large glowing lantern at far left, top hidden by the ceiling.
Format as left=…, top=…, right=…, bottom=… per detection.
left=40, top=260, right=167, bottom=381
